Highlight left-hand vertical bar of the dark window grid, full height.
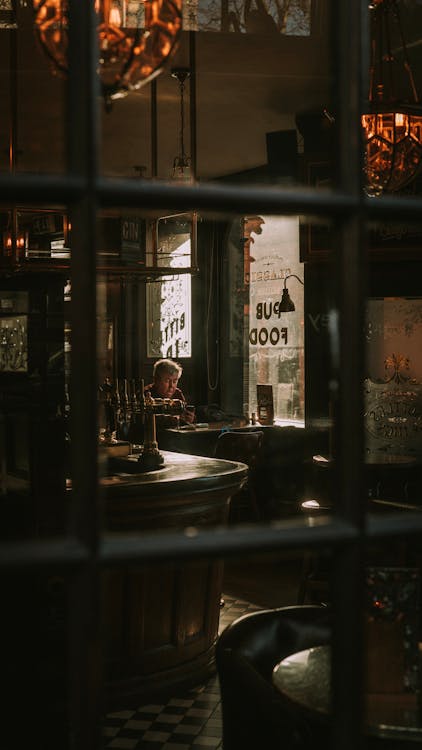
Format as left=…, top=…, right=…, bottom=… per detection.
left=67, top=0, right=102, bottom=750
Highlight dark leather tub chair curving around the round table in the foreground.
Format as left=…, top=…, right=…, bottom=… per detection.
left=216, top=605, right=331, bottom=750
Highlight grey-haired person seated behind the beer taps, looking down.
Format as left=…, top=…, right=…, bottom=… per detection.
left=144, top=359, right=195, bottom=427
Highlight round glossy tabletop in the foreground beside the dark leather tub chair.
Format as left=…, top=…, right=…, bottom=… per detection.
left=273, top=646, right=422, bottom=747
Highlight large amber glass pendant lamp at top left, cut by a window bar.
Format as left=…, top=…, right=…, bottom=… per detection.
left=33, top=0, right=182, bottom=105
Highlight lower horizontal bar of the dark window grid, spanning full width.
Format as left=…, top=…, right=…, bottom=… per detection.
left=0, top=513, right=422, bottom=568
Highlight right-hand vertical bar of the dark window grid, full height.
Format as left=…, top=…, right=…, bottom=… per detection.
left=332, top=0, right=365, bottom=750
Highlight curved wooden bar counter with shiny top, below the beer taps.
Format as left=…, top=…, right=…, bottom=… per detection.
left=102, top=451, right=247, bottom=710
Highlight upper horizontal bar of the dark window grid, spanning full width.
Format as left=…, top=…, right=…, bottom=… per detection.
left=0, top=174, right=422, bottom=219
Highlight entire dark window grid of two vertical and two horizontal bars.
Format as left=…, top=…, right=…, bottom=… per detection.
left=0, top=0, right=422, bottom=750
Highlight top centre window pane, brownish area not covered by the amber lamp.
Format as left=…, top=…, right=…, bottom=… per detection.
left=101, top=0, right=336, bottom=190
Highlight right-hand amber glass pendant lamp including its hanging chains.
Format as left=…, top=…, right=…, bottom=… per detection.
left=362, top=0, right=422, bottom=196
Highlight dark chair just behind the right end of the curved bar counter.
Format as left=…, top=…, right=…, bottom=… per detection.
left=215, top=430, right=264, bottom=521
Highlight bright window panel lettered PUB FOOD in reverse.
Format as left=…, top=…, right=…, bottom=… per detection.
left=244, top=216, right=304, bottom=419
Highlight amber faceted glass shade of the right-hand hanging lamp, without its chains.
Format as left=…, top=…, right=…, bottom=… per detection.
left=362, top=105, right=422, bottom=196
